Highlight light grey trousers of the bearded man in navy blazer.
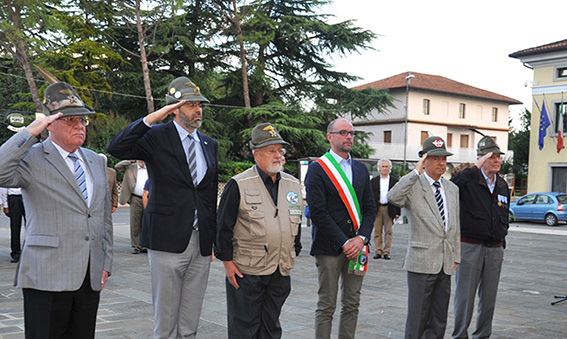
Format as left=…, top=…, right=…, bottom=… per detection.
left=148, top=231, right=211, bottom=339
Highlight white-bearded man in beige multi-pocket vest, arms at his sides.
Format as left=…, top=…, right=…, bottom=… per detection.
left=216, top=123, right=303, bottom=338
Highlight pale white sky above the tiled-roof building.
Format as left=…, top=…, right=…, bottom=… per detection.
left=321, top=0, right=567, bottom=127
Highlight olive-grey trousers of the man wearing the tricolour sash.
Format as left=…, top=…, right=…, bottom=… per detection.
left=315, top=253, right=364, bottom=339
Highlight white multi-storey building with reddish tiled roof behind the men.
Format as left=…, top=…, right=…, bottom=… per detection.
left=353, top=72, right=521, bottom=167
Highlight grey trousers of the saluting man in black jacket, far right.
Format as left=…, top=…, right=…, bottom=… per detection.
left=453, top=242, right=504, bottom=339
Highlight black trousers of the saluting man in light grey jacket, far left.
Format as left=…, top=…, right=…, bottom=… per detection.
left=23, top=270, right=100, bottom=339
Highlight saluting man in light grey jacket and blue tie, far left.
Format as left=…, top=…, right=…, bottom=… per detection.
left=0, top=82, right=113, bottom=339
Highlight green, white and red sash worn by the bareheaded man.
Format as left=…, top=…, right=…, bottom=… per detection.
left=316, top=152, right=368, bottom=275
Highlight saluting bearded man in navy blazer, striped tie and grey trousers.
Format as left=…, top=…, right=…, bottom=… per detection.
left=108, top=77, right=218, bottom=338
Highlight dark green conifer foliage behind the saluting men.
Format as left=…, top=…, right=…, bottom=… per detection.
left=0, top=0, right=392, bottom=167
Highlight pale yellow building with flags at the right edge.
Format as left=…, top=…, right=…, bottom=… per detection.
left=510, top=40, right=567, bottom=193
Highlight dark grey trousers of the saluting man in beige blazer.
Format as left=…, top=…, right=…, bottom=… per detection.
left=405, top=270, right=451, bottom=339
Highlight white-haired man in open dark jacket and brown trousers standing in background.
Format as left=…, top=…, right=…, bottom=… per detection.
left=370, top=159, right=400, bottom=260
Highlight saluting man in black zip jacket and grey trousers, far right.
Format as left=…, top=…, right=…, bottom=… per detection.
left=451, top=136, right=510, bottom=338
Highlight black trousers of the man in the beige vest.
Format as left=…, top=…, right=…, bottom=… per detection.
left=226, top=268, right=291, bottom=339
